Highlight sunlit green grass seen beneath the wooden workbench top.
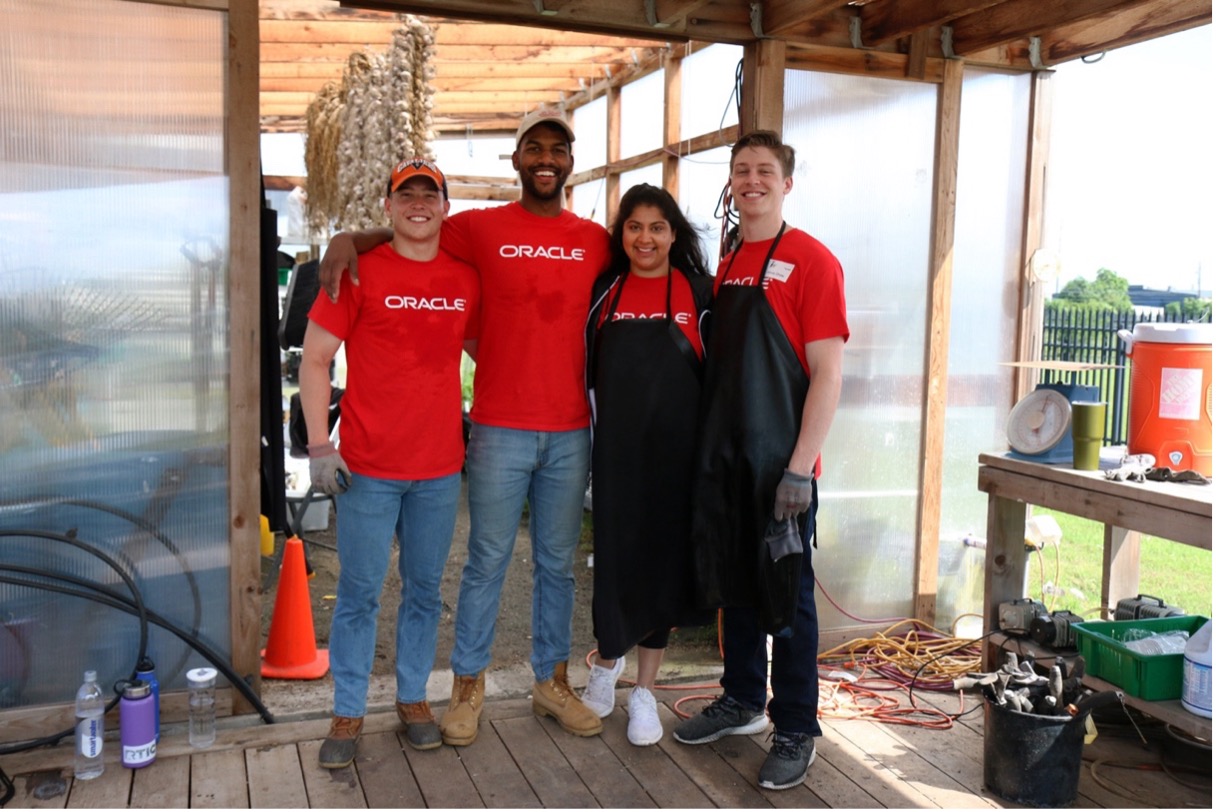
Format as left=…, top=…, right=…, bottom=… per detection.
left=1026, top=508, right=1212, bottom=620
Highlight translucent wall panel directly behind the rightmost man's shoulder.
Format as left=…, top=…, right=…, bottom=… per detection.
left=784, top=71, right=938, bottom=628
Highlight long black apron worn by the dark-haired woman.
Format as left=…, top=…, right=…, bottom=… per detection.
left=590, top=270, right=705, bottom=656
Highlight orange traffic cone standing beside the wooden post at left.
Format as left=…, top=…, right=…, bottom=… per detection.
left=261, top=536, right=330, bottom=680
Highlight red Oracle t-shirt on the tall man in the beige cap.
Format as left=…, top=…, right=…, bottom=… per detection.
left=440, top=203, right=608, bottom=432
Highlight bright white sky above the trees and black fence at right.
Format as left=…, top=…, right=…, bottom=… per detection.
left=1043, top=26, right=1216, bottom=296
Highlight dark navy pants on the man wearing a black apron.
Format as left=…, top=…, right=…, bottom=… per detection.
left=721, top=507, right=823, bottom=735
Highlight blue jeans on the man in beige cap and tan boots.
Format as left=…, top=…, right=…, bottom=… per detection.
left=451, top=423, right=591, bottom=682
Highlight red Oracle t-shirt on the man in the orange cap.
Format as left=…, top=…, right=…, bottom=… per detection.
left=309, top=243, right=480, bottom=479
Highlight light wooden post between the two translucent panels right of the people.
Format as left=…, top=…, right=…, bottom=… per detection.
left=913, top=60, right=963, bottom=624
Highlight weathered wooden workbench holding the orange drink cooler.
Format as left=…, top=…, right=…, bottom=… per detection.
left=979, top=453, right=1216, bottom=739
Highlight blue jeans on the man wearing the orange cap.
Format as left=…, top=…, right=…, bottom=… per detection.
left=330, top=474, right=460, bottom=716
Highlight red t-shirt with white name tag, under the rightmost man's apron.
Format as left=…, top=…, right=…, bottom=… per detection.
left=714, top=227, right=849, bottom=373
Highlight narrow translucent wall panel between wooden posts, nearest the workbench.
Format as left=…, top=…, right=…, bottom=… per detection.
left=936, top=68, right=1031, bottom=633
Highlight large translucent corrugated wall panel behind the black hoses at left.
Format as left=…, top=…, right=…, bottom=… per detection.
left=0, top=0, right=231, bottom=707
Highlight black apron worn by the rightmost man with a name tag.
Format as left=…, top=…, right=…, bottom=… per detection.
left=692, top=224, right=815, bottom=633
